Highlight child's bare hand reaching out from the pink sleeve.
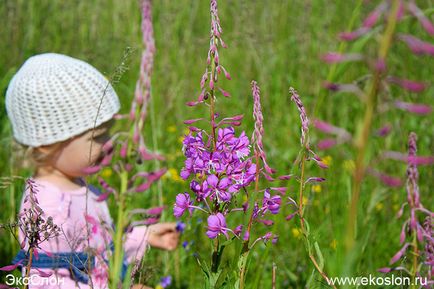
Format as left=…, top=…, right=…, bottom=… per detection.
left=148, top=223, right=179, bottom=251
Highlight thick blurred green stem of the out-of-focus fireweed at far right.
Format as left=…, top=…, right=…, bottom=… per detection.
left=345, top=0, right=399, bottom=252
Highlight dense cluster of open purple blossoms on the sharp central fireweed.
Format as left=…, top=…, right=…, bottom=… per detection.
left=181, top=125, right=256, bottom=202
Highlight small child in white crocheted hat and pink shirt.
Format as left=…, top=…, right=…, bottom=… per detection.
left=6, top=53, right=179, bottom=289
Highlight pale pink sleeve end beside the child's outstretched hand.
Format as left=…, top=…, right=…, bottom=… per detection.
left=124, top=226, right=149, bottom=263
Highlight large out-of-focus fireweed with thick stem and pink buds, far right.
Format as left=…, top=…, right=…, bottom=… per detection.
left=322, top=0, right=433, bottom=266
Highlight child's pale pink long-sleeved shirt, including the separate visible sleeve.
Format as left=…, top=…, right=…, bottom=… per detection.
left=19, top=180, right=148, bottom=289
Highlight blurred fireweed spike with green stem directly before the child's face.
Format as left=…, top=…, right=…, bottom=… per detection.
left=103, top=0, right=166, bottom=288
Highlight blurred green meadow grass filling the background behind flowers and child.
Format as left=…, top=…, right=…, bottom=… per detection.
left=0, top=0, right=434, bottom=288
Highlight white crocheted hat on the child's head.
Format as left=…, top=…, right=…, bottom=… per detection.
left=6, top=53, right=120, bottom=147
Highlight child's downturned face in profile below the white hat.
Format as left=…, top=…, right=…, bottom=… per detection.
left=48, top=122, right=112, bottom=177
